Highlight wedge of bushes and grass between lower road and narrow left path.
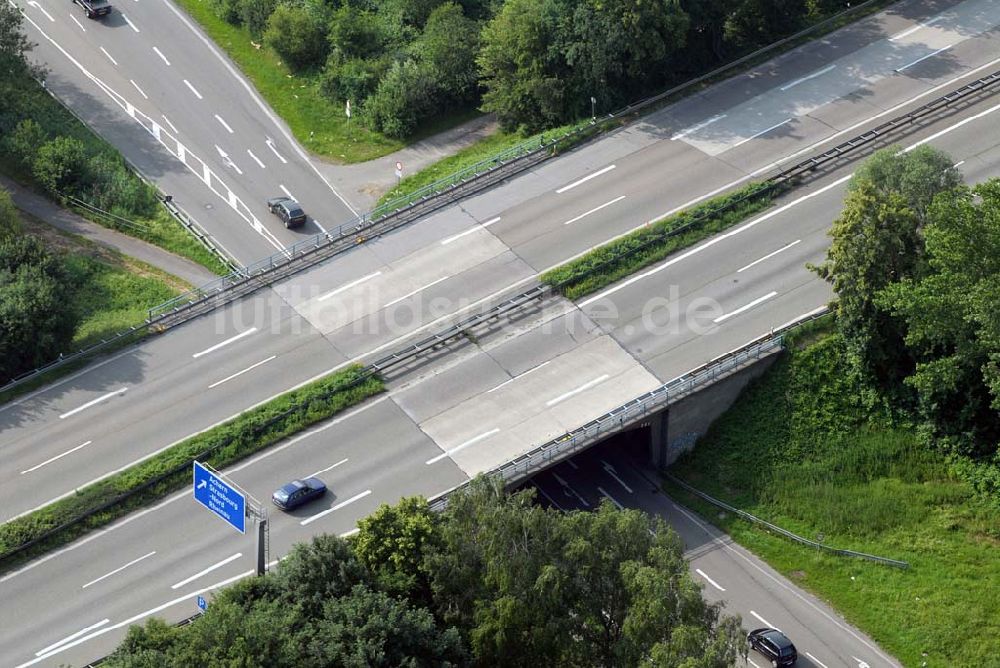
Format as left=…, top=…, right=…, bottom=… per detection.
left=0, top=3, right=227, bottom=274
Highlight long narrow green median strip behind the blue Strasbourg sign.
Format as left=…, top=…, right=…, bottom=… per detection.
left=0, top=365, right=384, bottom=571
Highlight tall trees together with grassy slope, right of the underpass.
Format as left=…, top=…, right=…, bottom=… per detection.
left=667, top=147, right=1000, bottom=667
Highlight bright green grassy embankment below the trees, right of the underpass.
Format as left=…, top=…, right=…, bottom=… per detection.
left=665, top=332, right=1000, bottom=667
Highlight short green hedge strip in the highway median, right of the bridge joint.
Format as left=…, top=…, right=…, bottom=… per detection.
left=541, top=183, right=776, bottom=299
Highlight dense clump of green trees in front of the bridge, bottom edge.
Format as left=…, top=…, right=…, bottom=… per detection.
left=104, top=478, right=745, bottom=668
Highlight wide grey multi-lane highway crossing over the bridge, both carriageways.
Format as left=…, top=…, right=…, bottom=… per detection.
left=0, top=4, right=1000, bottom=666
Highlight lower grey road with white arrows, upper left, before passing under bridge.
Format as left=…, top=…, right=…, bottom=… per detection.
left=19, top=0, right=357, bottom=264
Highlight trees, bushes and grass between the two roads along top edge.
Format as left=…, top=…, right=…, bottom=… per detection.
left=180, top=0, right=860, bottom=162
